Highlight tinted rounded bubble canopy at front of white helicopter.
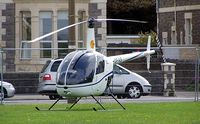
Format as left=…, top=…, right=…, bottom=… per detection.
left=57, top=51, right=99, bottom=85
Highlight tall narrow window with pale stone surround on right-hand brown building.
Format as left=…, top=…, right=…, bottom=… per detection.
left=185, top=13, right=192, bottom=45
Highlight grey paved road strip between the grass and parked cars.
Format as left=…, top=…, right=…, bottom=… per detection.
left=0, top=92, right=200, bottom=104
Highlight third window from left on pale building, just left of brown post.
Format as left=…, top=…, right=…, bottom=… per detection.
left=57, top=10, right=69, bottom=58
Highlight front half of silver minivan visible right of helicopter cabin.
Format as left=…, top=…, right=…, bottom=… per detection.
left=107, top=65, right=152, bottom=98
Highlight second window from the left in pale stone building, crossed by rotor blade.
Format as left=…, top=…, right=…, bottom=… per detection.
left=39, top=11, right=53, bottom=58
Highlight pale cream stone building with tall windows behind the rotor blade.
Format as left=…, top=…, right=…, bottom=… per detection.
left=0, top=0, right=107, bottom=72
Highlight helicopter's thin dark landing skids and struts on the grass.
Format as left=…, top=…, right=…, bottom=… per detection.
left=35, top=94, right=126, bottom=111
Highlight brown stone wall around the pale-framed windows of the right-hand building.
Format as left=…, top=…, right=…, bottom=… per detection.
left=159, top=0, right=200, bottom=45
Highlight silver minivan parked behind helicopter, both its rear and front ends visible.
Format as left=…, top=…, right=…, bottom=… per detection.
left=38, top=59, right=151, bottom=99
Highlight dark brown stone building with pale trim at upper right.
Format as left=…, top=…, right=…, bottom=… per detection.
left=157, top=0, right=200, bottom=59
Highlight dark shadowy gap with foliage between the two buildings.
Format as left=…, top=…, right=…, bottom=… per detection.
left=107, top=0, right=156, bottom=34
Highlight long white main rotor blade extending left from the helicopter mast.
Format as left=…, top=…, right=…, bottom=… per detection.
left=28, top=20, right=88, bottom=42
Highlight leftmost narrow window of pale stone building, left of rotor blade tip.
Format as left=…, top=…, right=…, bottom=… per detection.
left=20, top=11, right=31, bottom=59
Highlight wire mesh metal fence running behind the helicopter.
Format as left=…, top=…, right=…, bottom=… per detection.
left=1, top=47, right=199, bottom=101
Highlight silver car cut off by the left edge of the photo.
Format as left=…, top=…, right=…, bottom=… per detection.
left=0, top=81, right=15, bottom=98
